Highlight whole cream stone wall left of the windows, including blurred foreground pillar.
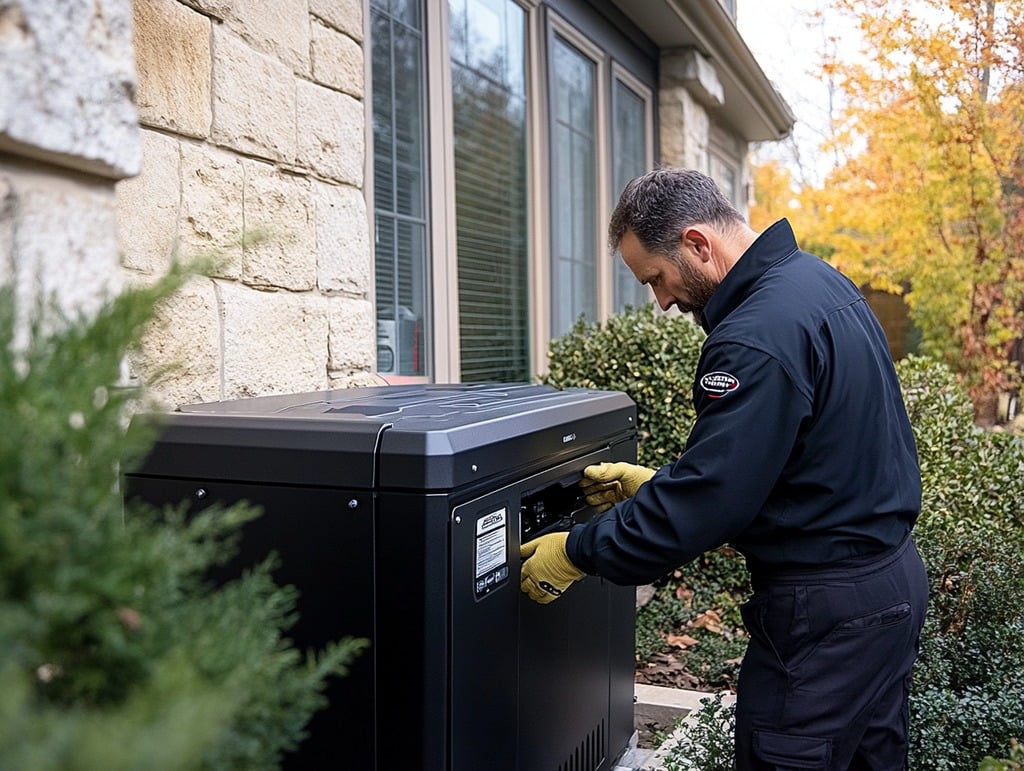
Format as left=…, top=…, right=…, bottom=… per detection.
left=0, top=0, right=376, bottom=405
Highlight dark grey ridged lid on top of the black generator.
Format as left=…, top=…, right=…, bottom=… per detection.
left=133, top=384, right=636, bottom=490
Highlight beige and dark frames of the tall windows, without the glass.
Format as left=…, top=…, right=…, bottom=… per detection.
left=362, top=0, right=657, bottom=383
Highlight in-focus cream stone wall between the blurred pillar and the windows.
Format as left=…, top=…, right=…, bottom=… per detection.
left=117, top=0, right=376, bottom=403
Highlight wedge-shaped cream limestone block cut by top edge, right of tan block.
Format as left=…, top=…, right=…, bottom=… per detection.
left=221, top=0, right=309, bottom=75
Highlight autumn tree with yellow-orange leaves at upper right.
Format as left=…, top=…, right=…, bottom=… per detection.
left=801, top=0, right=1024, bottom=422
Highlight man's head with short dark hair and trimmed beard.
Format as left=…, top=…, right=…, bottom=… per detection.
left=608, top=168, right=756, bottom=313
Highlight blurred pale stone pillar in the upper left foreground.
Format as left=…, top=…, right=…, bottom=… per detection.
left=0, top=0, right=140, bottom=341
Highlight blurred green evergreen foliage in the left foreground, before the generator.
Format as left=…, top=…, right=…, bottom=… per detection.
left=0, top=267, right=366, bottom=771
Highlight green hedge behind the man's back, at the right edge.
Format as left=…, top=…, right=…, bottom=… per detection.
left=898, top=357, right=1024, bottom=771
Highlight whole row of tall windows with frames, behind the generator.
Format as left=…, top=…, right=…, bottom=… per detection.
left=368, top=0, right=657, bottom=383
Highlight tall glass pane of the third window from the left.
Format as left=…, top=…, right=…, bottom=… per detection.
left=550, top=36, right=597, bottom=338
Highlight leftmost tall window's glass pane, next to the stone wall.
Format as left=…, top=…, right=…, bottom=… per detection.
left=371, top=0, right=430, bottom=376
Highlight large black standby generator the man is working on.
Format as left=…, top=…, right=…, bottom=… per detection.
left=125, top=385, right=637, bottom=771
